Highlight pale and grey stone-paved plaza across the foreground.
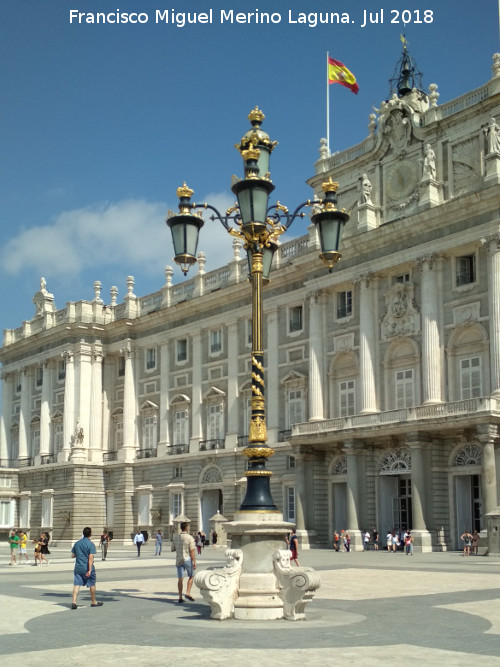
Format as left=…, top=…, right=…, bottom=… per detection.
left=0, top=543, right=500, bottom=666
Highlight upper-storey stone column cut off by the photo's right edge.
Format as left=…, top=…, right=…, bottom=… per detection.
left=481, top=234, right=500, bottom=396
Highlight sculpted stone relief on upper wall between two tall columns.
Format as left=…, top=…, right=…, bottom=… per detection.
left=381, top=283, right=420, bottom=340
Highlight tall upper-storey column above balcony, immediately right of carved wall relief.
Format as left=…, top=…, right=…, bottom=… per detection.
left=419, top=255, right=443, bottom=404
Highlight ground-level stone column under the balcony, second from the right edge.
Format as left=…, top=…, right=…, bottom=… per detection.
left=406, top=433, right=432, bottom=551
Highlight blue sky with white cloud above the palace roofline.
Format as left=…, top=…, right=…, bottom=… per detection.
left=0, top=0, right=500, bottom=329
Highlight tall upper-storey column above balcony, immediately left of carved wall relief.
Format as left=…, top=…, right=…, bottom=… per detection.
left=357, top=276, right=379, bottom=414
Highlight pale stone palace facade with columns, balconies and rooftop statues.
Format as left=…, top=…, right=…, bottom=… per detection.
left=0, top=54, right=500, bottom=550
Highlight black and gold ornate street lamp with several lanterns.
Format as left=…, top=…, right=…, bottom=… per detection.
left=167, top=107, right=349, bottom=512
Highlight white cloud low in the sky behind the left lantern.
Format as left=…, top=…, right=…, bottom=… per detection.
left=0, top=193, right=238, bottom=284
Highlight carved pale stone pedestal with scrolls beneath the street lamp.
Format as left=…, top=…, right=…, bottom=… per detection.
left=194, top=512, right=319, bottom=621
